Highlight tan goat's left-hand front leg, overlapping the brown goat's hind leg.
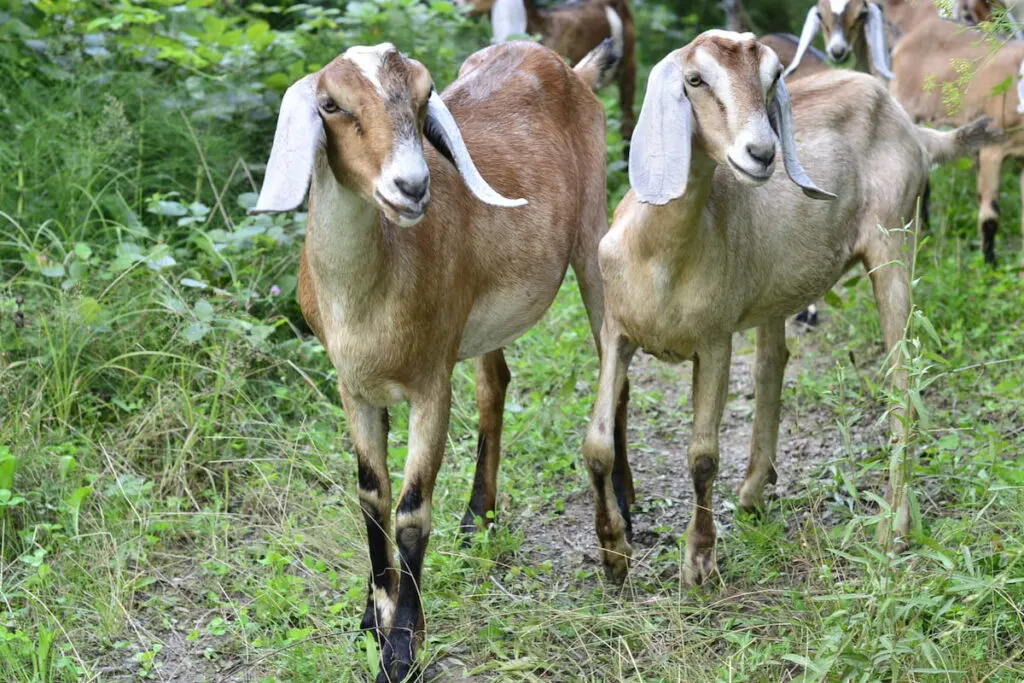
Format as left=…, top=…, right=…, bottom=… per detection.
left=583, top=318, right=636, bottom=581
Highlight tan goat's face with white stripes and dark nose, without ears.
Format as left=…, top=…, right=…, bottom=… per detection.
left=678, top=32, right=782, bottom=185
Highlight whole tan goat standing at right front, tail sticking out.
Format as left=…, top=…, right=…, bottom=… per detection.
left=584, top=31, right=989, bottom=584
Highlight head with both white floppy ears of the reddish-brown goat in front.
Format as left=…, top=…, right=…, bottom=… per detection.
left=253, top=43, right=525, bottom=227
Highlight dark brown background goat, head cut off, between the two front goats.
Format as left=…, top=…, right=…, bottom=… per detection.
left=456, top=0, right=637, bottom=156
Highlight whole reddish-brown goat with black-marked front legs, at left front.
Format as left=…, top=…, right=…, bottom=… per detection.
left=255, top=41, right=618, bottom=682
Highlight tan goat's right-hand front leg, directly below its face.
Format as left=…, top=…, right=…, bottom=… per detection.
left=683, top=338, right=732, bottom=586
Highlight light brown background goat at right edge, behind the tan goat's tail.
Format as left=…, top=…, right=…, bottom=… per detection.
left=886, top=0, right=1024, bottom=263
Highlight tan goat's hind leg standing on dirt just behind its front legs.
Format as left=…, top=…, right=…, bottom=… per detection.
left=739, top=319, right=790, bottom=512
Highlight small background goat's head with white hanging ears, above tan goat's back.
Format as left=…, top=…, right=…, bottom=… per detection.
left=785, top=0, right=893, bottom=79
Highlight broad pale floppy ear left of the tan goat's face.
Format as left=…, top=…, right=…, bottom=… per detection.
left=630, top=54, right=694, bottom=206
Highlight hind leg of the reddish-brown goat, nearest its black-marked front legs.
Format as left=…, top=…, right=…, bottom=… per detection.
left=462, top=349, right=512, bottom=543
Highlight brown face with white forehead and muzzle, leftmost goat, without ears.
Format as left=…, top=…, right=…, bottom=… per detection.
left=315, top=43, right=432, bottom=227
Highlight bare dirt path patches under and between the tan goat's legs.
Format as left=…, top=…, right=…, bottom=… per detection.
left=517, top=330, right=884, bottom=575
